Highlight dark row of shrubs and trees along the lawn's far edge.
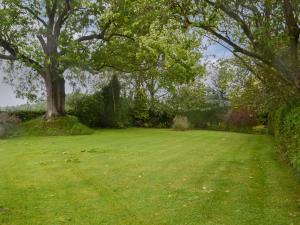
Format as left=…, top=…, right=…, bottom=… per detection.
left=0, top=69, right=265, bottom=132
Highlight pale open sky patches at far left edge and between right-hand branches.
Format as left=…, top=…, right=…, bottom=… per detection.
left=0, top=44, right=230, bottom=107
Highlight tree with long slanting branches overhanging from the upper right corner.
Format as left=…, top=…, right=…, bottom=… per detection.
left=167, top=0, right=300, bottom=92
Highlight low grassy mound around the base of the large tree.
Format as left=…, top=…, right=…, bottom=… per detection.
left=8, top=116, right=93, bottom=137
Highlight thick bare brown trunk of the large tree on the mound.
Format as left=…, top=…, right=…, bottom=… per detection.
left=45, top=74, right=65, bottom=119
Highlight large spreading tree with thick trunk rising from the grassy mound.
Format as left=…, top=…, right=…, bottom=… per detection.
left=0, top=0, right=144, bottom=118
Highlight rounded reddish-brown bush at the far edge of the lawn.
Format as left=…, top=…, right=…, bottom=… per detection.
left=225, top=107, right=257, bottom=131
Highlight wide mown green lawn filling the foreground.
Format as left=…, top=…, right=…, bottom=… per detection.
left=0, top=129, right=300, bottom=225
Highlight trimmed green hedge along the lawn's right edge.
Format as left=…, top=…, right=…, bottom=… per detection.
left=269, top=106, right=300, bottom=172
